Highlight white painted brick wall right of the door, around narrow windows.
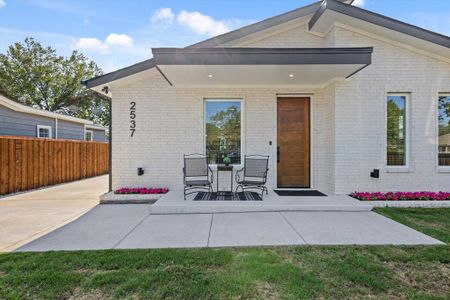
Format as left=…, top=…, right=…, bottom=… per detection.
left=334, top=27, right=450, bottom=193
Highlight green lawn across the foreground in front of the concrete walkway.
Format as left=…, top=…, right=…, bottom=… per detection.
left=0, top=209, right=450, bottom=299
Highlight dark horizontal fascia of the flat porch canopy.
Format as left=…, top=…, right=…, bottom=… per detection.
left=152, top=47, right=373, bottom=65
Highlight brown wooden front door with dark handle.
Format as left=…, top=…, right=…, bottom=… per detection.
left=277, top=97, right=311, bottom=188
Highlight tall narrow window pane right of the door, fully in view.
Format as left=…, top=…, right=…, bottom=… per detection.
left=387, top=96, right=407, bottom=166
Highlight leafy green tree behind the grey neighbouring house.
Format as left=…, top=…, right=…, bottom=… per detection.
left=0, top=38, right=109, bottom=125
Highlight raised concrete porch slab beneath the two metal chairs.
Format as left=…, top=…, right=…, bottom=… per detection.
left=152, top=191, right=372, bottom=215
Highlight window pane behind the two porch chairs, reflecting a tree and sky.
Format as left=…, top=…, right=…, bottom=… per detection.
left=205, top=101, right=241, bottom=164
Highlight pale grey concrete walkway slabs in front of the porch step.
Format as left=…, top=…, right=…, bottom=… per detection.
left=18, top=204, right=442, bottom=251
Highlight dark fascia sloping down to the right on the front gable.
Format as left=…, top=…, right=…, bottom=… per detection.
left=309, top=0, right=450, bottom=48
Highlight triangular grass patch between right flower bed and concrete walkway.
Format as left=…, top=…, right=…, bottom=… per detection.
left=374, top=208, right=450, bottom=244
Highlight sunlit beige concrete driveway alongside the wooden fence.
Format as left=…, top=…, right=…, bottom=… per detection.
left=0, top=176, right=108, bottom=252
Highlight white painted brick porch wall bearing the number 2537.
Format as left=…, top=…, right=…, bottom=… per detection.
left=112, top=73, right=329, bottom=190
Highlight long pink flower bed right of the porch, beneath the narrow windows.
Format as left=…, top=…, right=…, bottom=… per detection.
left=350, top=192, right=450, bottom=201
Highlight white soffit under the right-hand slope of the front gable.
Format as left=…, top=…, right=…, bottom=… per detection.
left=311, top=9, right=450, bottom=59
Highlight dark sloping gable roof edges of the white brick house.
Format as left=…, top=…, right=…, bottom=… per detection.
left=82, top=0, right=450, bottom=88
